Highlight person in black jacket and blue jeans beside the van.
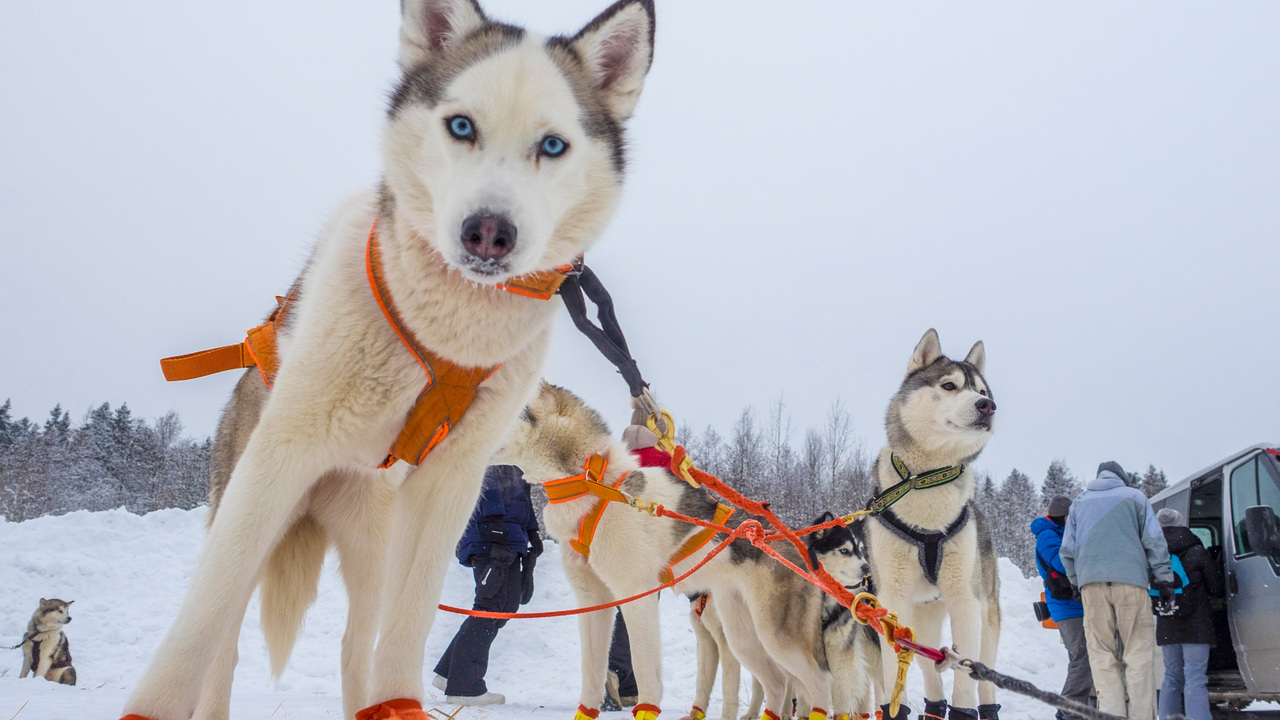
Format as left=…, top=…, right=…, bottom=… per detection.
left=1156, top=507, right=1222, bottom=720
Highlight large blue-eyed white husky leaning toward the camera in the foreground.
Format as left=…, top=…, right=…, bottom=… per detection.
left=127, top=0, right=654, bottom=720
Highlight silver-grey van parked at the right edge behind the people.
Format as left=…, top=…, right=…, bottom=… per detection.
left=1151, top=443, right=1280, bottom=710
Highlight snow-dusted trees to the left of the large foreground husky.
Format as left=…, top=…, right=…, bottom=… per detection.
left=0, top=400, right=211, bottom=521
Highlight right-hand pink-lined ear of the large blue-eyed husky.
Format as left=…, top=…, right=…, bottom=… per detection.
left=570, top=0, right=654, bottom=120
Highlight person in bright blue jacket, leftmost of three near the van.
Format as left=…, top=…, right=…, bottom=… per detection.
left=1032, top=495, right=1093, bottom=720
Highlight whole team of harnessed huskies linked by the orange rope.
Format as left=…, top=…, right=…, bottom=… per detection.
left=117, top=0, right=1000, bottom=720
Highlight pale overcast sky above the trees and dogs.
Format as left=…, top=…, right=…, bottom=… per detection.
left=0, top=0, right=1280, bottom=482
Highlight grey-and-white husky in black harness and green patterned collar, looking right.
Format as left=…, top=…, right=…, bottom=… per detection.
left=863, top=329, right=1000, bottom=720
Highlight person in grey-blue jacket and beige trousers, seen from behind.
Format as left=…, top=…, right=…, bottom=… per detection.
left=1059, top=461, right=1178, bottom=720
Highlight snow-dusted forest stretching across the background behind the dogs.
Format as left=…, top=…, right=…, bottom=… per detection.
left=0, top=392, right=1166, bottom=575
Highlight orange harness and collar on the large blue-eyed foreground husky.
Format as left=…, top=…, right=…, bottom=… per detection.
left=160, top=222, right=573, bottom=468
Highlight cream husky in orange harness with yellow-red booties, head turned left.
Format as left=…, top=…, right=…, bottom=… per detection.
left=494, top=384, right=880, bottom=717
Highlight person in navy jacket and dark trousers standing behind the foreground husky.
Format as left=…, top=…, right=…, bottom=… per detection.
left=431, top=465, right=543, bottom=705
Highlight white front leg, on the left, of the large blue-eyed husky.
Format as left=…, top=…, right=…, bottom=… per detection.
left=125, top=420, right=333, bottom=720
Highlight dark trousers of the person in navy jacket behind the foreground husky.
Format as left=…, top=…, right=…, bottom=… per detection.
left=435, top=556, right=521, bottom=697
